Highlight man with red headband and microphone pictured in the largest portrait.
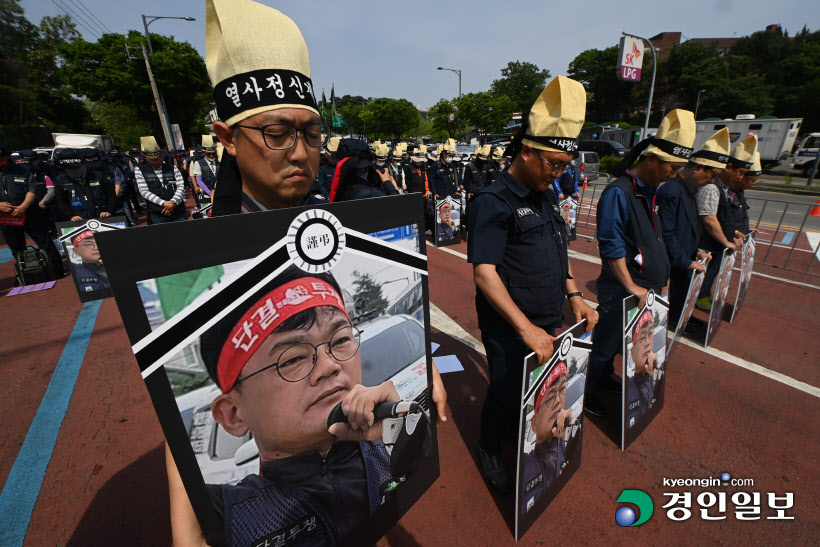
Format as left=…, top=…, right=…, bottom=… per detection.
left=201, top=267, right=429, bottom=545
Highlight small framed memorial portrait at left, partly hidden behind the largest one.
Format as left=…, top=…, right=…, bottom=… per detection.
left=56, top=217, right=127, bottom=302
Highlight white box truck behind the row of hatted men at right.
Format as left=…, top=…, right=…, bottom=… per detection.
left=695, top=114, right=803, bottom=169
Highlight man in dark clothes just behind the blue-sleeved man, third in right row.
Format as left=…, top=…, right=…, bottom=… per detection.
left=657, top=127, right=731, bottom=329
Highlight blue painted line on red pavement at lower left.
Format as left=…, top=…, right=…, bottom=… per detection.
left=0, top=300, right=102, bottom=547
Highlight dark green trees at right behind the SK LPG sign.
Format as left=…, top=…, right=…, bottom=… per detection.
left=568, top=28, right=820, bottom=132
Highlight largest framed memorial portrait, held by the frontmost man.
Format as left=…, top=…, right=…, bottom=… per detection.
left=95, top=195, right=439, bottom=546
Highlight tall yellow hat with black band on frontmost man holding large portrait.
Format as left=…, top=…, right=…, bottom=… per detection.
left=205, top=0, right=319, bottom=125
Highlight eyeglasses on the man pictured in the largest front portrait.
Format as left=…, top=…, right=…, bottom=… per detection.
left=234, top=325, right=361, bottom=385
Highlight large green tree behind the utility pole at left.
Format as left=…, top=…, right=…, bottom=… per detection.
left=61, top=30, right=212, bottom=148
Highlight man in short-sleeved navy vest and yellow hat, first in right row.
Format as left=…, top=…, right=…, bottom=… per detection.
left=467, top=76, right=597, bottom=492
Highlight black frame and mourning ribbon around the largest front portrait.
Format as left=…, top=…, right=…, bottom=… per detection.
left=94, top=195, right=439, bottom=546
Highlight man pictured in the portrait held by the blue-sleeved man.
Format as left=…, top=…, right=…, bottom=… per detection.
left=626, top=309, right=658, bottom=428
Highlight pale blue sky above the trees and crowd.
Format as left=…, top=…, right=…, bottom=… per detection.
left=22, top=0, right=820, bottom=108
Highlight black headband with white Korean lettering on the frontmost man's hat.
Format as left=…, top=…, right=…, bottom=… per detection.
left=214, top=69, right=316, bottom=124
